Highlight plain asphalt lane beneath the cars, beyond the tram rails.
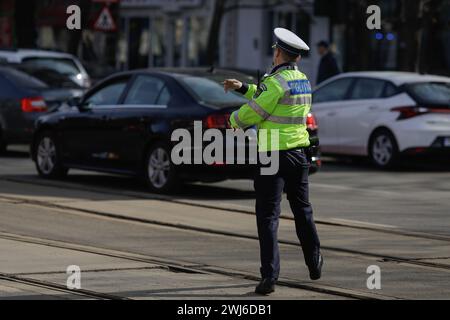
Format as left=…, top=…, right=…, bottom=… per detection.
left=0, top=147, right=450, bottom=235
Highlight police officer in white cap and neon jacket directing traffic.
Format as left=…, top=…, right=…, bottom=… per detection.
left=223, top=28, right=323, bottom=294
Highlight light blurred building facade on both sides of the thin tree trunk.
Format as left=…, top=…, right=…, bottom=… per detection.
left=118, top=0, right=329, bottom=84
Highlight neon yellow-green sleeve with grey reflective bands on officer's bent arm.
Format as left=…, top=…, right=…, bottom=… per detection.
left=230, top=79, right=283, bottom=129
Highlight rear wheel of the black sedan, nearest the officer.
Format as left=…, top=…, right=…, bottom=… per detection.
left=145, top=143, right=179, bottom=193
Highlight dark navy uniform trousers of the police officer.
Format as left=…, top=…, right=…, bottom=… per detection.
left=254, top=149, right=320, bottom=280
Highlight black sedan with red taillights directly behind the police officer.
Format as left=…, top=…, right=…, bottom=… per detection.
left=31, top=69, right=320, bottom=192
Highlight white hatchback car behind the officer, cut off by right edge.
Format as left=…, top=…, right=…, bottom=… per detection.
left=312, top=72, right=450, bottom=168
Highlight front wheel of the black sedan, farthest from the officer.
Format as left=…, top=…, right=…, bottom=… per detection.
left=35, top=133, right=68, bottom=178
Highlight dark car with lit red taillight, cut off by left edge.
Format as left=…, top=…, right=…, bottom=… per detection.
left=0, top=67, right=80, bottom=151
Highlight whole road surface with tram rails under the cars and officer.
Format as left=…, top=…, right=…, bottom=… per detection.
left=0, top=148, right=450, bottom=299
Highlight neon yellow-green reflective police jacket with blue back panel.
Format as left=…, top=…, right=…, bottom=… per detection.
left=230, top=64, right=312, bottom=152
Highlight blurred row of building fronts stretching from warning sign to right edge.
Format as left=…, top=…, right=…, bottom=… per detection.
left=112, top=0, right=450, bottom=83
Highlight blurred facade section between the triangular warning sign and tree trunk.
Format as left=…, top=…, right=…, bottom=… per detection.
left=117, top=0, right=215, bottom=69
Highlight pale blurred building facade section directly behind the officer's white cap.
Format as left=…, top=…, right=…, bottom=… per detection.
left=219, top=0, right=330, bottom=83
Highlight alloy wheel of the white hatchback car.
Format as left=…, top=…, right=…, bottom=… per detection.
left=369, top=130, right=399, bottom=169
